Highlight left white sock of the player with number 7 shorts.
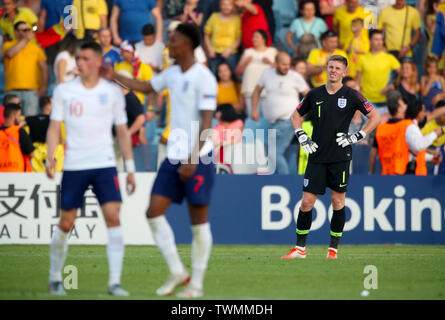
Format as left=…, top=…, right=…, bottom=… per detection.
left=147, top=215, right=185, bottom=274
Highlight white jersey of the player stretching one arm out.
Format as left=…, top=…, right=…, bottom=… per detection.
left=150, top=63, right=218, bottom=160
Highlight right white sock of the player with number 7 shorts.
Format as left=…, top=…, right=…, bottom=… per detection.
left=190, top=222, right=213, bottom=289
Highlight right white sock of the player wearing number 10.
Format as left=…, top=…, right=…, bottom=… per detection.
left=107, top=226, right=125, bottom=286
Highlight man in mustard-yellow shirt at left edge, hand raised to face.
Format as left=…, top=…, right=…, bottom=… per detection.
left=2, top=21, right=49, bottom=116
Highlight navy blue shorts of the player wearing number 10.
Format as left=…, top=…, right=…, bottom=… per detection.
left=61, top=167, right=122, bottom=210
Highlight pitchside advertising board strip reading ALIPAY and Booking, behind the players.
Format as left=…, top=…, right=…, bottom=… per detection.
left=0, top=173, right=445, bottom=245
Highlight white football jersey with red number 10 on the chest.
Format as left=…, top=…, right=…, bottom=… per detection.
left=50, top=78, right=127, bottom=170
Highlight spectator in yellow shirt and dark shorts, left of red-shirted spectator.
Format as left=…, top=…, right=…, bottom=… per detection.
left=204, top=0, right=241, bottom=74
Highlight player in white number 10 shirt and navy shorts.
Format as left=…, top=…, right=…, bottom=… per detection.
left=46, top=42, right=136, bottom=296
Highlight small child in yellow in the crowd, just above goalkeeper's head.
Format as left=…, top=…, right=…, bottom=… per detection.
left=345, top=18, right=369, bottom=79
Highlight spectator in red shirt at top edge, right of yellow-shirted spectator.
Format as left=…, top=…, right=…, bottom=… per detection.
left=235, top=0, right=272, bottom=49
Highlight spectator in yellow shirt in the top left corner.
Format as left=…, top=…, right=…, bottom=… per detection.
left=0, top=0, right=38, bottom=41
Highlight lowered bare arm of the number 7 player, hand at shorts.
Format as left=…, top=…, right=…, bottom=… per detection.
left=178, top=110, right=213, bottom=181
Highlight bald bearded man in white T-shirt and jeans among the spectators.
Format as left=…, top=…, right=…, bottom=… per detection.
left=251, top=52, right=309, bottom=174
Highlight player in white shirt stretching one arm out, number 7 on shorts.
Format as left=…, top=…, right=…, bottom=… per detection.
left=103, top=23, right=217, bottom=298
